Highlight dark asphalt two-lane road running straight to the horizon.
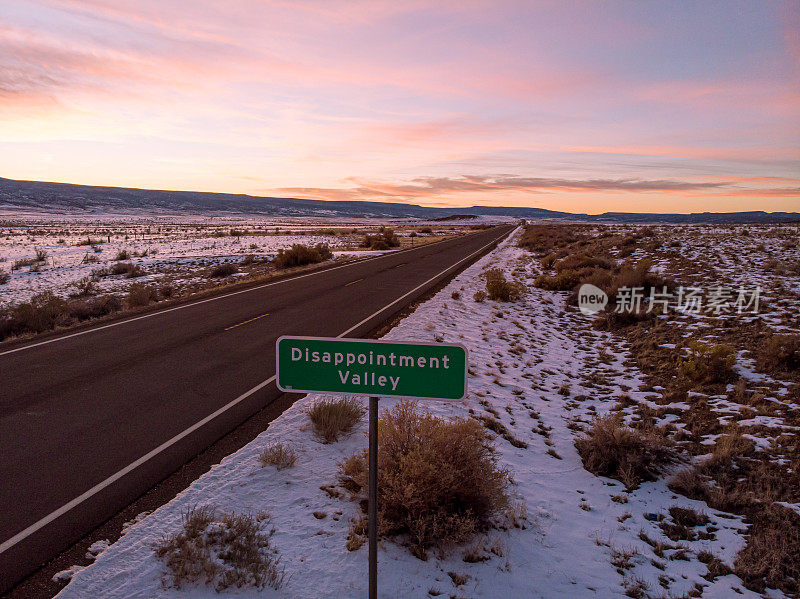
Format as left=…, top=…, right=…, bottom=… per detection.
left=0, top=226, right=512, bottom=592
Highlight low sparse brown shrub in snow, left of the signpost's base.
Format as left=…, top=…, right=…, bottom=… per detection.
left=154, top=506, right=284, bottom=591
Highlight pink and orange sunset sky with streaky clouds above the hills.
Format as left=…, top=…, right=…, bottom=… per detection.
left=0, top=0, right=800, bottom=213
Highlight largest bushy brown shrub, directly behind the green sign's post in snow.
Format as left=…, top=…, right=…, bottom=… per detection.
left=340, top=402, right=509, bottom=559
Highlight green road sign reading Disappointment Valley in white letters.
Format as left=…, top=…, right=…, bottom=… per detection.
left=276, top=337, right=467, bottom=399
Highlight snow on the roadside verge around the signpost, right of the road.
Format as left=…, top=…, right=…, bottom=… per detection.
left=53, top=230, right=756, bottom=599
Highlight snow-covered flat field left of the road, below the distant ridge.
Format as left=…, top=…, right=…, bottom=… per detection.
left=0, top=216, right=473, bottom=308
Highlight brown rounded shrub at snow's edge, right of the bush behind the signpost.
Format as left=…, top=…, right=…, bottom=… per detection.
left=575, top=416, right=677, bottom=488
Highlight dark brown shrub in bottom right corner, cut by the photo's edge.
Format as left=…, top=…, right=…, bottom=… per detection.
left=734, top=505, right=800, bottom=595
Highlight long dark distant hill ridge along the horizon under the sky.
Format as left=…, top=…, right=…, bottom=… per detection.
left=0, top=177, right=800, bottom=223
